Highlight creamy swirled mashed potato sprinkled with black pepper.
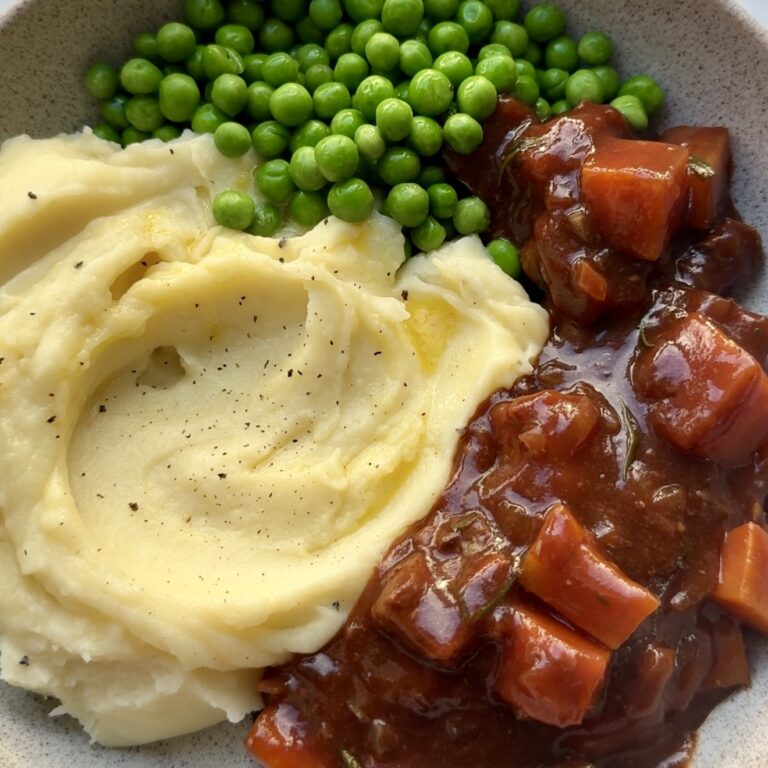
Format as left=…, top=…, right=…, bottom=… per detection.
left=0, top=135, right=547, bottom=745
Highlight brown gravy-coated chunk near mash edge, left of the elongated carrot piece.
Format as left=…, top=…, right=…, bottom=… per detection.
left=371, top=555, right=473, bottom=663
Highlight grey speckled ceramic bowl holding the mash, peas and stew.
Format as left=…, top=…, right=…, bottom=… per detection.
left=0, top=0, right=768, bottom=768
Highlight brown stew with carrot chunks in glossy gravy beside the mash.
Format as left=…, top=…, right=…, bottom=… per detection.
left=249, top=101, right=768, bottom=768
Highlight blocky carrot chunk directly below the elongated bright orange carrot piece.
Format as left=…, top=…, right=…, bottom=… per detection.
left=494, top=604, right=611, bottom=728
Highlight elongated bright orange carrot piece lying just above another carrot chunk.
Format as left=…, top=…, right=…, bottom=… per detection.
left=519, top=504, right=659, bottom=649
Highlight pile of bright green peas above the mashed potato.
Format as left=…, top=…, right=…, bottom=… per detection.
left=85, top=0, right=664, bottom=275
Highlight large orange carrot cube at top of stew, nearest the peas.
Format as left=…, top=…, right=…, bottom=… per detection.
left=581, top=138, right=688, bottom=261
